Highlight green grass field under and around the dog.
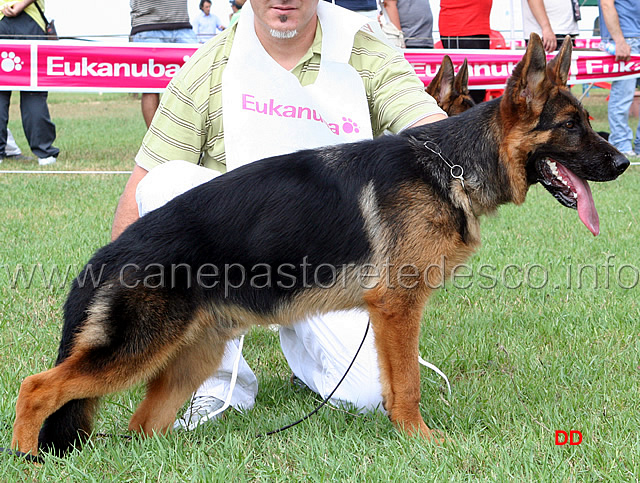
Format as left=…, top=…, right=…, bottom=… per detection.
left=0, top=89, right=640, bottom=482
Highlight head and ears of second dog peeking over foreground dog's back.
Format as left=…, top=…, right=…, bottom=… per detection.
left=425, top=55, right=476, bottom=116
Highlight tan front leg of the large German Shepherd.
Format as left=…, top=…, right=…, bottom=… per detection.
left=366, top=291, right=434, bottom=439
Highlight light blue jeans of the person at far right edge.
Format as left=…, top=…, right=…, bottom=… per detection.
left=609, top=38, right=640, bottom=155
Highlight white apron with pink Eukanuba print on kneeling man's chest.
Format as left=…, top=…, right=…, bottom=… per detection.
left=222, top=1, right=372, bottom=170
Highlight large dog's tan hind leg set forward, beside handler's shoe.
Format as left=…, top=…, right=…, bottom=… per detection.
left=129, top=331, right=225, bottom=435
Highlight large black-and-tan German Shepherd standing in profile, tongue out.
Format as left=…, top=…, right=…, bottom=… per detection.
left=12, top=35, right=629, bottom=456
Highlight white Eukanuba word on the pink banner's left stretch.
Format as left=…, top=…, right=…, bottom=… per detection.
left=47, top=56, right=181, bottom=77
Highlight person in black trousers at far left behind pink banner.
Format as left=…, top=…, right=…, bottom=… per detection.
left=0, top=0, right=60, bottom=166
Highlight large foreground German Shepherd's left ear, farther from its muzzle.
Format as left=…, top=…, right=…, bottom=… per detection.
left=505, top=33, right=548, bottom=105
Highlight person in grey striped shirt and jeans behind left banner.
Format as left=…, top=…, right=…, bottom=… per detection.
left=129, top=0, right=198, bottom=128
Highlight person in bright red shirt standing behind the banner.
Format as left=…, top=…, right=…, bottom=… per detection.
left=438, top=0, right=492, bottom=104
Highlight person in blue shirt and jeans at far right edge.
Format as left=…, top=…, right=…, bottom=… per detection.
left=599, top=0, right=640, bottom=157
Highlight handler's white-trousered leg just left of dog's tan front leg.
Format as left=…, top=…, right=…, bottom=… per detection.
left=280, top=310, right=383, bottom=411
